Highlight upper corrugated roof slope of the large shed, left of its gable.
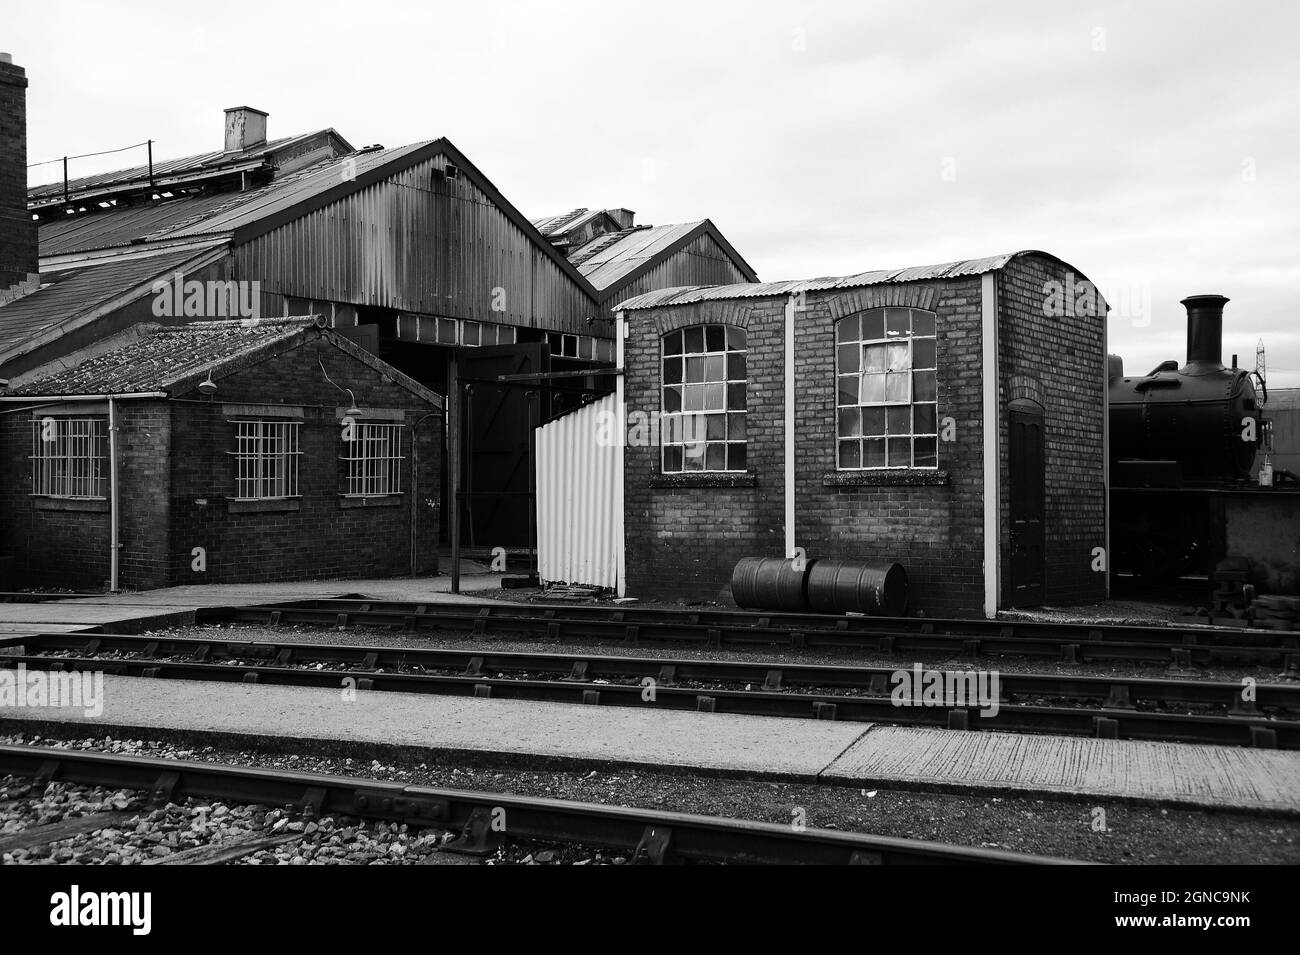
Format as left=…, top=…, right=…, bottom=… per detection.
left=39, top=143, right=426, bottom=256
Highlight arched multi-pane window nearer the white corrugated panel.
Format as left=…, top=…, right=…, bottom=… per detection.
left=659, top=325, right=745, bottom=474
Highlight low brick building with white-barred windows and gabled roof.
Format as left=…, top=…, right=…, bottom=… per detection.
left=0, top=318, right=442, bottom=590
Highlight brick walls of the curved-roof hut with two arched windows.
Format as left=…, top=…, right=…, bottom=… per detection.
left=624, top=256, right=1105, bottom=616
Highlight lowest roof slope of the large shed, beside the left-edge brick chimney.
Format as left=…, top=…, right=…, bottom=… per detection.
left=0, top=249, right=205, bottom=352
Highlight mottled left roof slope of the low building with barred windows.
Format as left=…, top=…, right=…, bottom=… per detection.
left=8, top=316, right=319, bottom=396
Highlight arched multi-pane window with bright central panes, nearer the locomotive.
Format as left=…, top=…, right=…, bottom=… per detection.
left=835, top=308, right=939, bottom=470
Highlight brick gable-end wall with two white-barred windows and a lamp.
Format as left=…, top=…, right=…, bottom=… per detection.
left=168, top=342, right=442, bottom=583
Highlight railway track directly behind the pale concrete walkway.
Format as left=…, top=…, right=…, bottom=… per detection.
left=0, top=633, right=1300, bottom=748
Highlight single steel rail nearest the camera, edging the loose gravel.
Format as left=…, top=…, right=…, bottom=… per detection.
left=0, top=746, right=1075, bottom=865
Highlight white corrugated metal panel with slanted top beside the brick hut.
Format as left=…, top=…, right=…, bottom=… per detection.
left=537, top=395, right=619, bottom=589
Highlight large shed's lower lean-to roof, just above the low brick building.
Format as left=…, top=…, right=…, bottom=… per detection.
left=0, top=249, right=219, bottom=361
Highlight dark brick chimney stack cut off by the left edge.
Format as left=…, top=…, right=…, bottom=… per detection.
left=0, top=53, right=40, bottom=291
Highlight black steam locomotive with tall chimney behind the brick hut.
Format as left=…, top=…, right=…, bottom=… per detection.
left=1108, top=295, right=1295, bottom=579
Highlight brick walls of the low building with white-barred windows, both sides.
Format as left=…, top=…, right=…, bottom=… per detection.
left=0, top=340, right=442, bottom=590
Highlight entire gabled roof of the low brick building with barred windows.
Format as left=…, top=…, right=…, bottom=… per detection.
left=5, top=316, right=442, bottom=408
